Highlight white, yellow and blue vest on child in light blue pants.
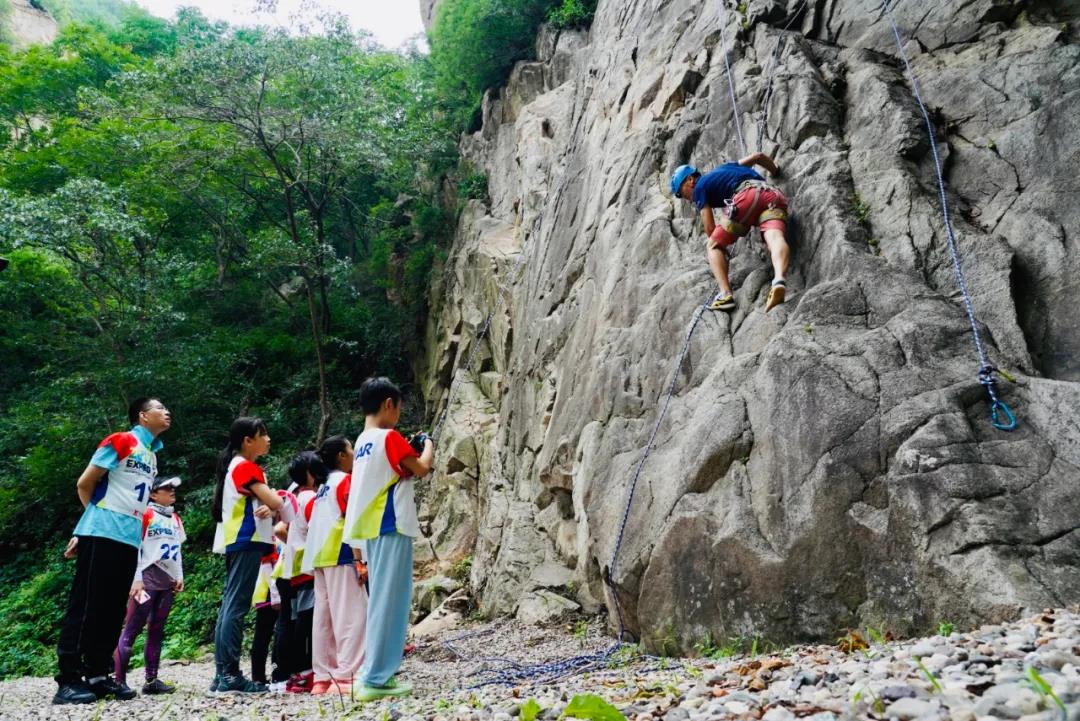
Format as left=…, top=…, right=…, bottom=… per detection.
left=342, top=428, right=420, bottom=539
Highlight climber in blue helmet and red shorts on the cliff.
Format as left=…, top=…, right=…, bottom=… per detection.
left=672, top=152, right=789, bottom=312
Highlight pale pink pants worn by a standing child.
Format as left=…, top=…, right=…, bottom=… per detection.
left=311, top=564, right=367, bottom=683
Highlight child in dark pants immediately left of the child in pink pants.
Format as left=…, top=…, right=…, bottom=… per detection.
left=273, top=451, right=329, bottom=693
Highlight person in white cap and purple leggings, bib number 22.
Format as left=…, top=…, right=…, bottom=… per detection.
left=113, top=478, right=187, bottom=694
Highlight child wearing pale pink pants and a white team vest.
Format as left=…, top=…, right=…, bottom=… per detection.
left=303, top=436, right=367, bottom=694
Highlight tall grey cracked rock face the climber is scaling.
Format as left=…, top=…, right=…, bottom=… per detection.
left=420, top=0, right=1080, bottom=649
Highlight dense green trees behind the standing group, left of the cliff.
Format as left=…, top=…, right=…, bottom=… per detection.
left=0, top=11, right=457, bottom=677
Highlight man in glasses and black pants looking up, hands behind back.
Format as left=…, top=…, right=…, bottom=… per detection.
left=53, top=398, right=172, bottom=704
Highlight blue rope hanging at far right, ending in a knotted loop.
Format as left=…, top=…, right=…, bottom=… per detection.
left=881, top=0, right=1018, bottom=431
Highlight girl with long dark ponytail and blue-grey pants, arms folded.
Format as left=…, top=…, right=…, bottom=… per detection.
left=210, top=418, right=283, bottom=693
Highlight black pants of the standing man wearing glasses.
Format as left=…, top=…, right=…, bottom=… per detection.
left=56, top=535, right=138, bottom=685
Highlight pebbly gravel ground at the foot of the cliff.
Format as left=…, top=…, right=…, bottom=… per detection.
left=0, top=609, right=1080, bottom=721
